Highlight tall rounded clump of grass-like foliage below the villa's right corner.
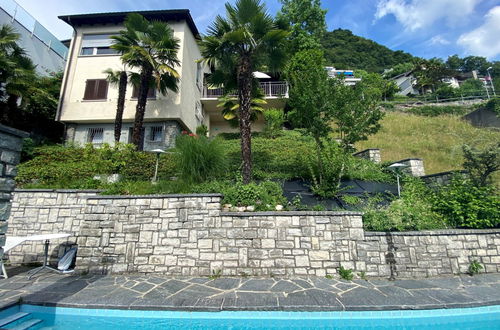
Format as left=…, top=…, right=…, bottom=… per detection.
left=175, top=134, right=226, bottom=183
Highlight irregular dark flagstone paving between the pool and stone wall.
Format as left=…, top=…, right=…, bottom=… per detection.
left=0, top=273, right=500, bottom=311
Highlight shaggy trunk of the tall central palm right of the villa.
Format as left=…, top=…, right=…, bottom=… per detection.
left=238, top=56, right=253, bottom=184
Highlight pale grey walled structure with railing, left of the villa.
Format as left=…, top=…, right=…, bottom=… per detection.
left=0, top=0, right=68, bottom=75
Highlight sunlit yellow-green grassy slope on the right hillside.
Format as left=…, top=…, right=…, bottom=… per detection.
left=356, top=112, right=500, bottom=174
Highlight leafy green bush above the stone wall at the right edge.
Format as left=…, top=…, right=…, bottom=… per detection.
left=434, top=175, right=500, bottom=228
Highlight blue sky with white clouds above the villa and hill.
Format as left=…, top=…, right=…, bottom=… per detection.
left=11, top=0, right=500, bottom=60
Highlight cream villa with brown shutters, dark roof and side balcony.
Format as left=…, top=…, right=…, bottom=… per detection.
left=56, top=9, right=288, bottom=150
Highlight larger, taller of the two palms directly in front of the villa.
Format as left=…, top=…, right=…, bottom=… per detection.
left=111, top=13, right=180, bottom=150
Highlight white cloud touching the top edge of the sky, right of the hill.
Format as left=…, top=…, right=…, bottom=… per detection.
left=375, top=0, right=481, bottom=31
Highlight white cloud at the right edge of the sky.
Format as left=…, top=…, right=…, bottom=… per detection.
left=457, top=6, right=500, bottom=58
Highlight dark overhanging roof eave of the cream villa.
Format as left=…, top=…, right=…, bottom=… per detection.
left=58, top=9, right=200, bottom=39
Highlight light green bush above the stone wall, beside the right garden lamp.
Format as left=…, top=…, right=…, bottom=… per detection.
left=363, top=177, right=446, bottom=231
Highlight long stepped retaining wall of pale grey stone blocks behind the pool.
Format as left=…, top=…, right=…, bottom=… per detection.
left=8, top=190, right=500, bottom=278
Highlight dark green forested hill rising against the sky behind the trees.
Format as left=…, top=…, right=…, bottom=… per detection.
left=323, top=29, right=414, bottom=73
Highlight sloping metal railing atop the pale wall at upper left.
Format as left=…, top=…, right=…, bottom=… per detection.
left=0, top=0, right=68, bottom=59
